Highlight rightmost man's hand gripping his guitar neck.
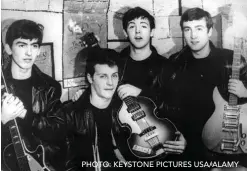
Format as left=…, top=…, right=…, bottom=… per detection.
left=228, top=79, right=247, bottom=98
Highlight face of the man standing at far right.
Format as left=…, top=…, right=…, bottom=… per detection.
left=183, top=18, right=212, bottom=52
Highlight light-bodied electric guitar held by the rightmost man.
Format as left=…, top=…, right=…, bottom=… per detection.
left=202, top=38, right=247, bottom=154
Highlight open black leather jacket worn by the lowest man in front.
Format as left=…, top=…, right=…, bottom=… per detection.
left=64, top=89, right=129, bottom=171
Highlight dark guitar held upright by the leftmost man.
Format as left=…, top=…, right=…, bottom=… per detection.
left=2, top=69, right=50, bottom=171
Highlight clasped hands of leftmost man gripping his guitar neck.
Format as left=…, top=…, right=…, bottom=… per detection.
left=1, top=93, right=27, bottom=124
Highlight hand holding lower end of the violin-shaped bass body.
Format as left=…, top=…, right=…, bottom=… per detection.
left=163, top=131, right=187, bottom=154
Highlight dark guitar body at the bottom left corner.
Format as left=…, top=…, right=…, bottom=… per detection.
left=3, top=140, right=50, bottom=171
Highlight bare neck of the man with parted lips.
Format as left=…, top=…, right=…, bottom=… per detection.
left=130, top=44, right=152, bottom=61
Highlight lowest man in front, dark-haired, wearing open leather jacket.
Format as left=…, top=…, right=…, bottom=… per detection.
left=61, top=48, right=130, bottom=171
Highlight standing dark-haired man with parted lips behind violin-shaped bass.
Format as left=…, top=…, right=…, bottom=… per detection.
left=117, top=7, right=186, bottom=154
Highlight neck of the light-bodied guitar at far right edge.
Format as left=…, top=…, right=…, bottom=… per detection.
left=229, top=37, right=241, bottom=106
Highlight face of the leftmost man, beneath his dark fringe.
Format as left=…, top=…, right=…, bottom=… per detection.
left=6, top=38, right=40, bottom=70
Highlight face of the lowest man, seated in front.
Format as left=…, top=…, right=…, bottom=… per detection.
left=87, top=64, right=119, bottom=100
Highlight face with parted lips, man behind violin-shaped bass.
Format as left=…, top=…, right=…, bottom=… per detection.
left=124, top=18, right=153, bottom=49
